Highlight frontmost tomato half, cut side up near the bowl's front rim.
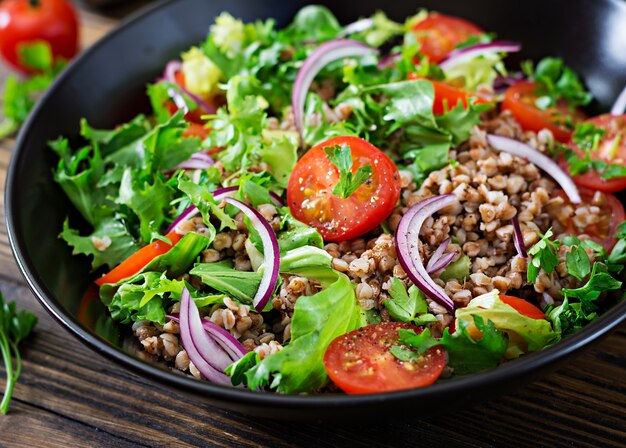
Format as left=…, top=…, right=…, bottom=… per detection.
left=324, top=322, right=446, bottom=394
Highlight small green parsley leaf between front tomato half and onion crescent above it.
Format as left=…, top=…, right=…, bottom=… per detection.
left=383, top=277, right=437, bottom=326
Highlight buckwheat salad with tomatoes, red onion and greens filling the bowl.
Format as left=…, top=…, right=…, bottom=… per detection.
left=50, top=6, right=626, bottom=394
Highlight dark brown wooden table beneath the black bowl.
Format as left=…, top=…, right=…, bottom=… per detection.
left=0, top=4, right=626, bottom=448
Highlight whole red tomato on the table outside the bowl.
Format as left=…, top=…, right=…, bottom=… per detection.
left=0, top=0, right=78, bottom=73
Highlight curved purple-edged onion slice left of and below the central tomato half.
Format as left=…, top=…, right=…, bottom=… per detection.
left=222, top=197, right=280, bottom=313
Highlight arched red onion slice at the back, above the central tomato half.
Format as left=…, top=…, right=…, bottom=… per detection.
left=291, top=39, right=378, bottom=142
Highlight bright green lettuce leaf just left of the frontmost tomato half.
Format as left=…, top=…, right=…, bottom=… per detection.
left=233, top=268, right=365, bottom=393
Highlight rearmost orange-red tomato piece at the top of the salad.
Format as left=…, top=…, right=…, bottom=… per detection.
left=413, top=13, right=485, bottom=62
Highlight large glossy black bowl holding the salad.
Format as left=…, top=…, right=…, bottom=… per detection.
left=6, top=0, right=626, bottom=418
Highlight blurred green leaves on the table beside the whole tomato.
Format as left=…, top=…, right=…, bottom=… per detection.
left=0, top=40, right=66, bottom=139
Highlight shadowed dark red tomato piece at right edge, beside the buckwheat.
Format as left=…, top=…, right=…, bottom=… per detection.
left=555, top=188, right=626, bottom=252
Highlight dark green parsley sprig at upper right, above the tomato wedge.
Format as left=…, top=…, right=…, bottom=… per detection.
left=522, top=57, right=593, bottom=109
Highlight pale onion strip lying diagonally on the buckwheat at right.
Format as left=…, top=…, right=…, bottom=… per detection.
left=487, top=134, right=581, bottom=204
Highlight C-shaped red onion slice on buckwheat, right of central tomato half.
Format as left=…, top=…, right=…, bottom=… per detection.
left=395, top=194, right=457, bottom=312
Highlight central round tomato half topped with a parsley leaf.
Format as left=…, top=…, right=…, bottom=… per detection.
left=287, top=137, right=400, bottom=241
